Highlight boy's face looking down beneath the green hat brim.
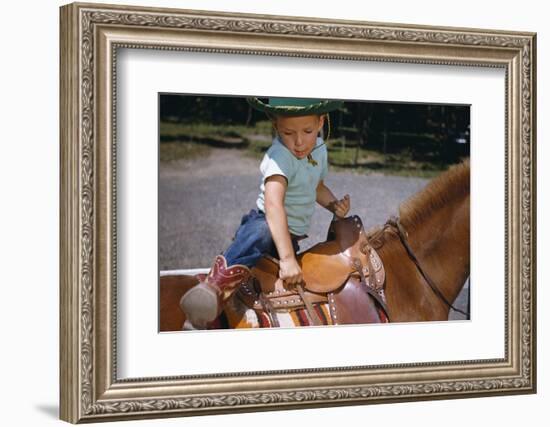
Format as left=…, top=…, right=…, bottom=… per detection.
left=274, top=115, right=325, bottom=159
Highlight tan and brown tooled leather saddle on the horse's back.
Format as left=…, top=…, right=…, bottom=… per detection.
left=237, top=216, right=389, bottom=326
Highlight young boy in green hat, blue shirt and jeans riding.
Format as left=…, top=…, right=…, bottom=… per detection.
left=180, top=98, right=350, bottom=329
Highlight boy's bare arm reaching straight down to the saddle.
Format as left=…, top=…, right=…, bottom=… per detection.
left=264, top=175, right=302, bottom=284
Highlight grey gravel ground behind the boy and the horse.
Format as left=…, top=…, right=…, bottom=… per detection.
left=159, top=149, right=468, bottom=319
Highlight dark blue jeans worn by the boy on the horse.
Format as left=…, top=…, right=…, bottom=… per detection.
left=223, top=209, right=300, bottom=268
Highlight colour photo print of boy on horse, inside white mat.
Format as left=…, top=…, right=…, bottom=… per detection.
left=158, top=93, right=470, bottom=332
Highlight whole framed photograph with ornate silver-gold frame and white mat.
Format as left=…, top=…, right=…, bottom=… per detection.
left=60, top=4, right=536, bottom=423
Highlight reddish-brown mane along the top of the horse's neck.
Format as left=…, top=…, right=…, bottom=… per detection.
left=399, top=160, right=470, bottom=230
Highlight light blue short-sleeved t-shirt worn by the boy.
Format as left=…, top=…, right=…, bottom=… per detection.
left=256, top=137, right=328, bottom=236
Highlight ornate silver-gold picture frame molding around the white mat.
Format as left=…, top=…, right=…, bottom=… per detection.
left=60, top=3, right=536, bottom=423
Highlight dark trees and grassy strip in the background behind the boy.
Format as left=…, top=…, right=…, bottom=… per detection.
left=159, top=94, right=470, bottom=176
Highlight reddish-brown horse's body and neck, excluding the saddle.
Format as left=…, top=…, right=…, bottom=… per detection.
left=159, top=162, right=470, bottom=331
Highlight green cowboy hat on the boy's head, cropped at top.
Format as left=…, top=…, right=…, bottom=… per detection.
left=246, top=97, right=344, bottom=116
